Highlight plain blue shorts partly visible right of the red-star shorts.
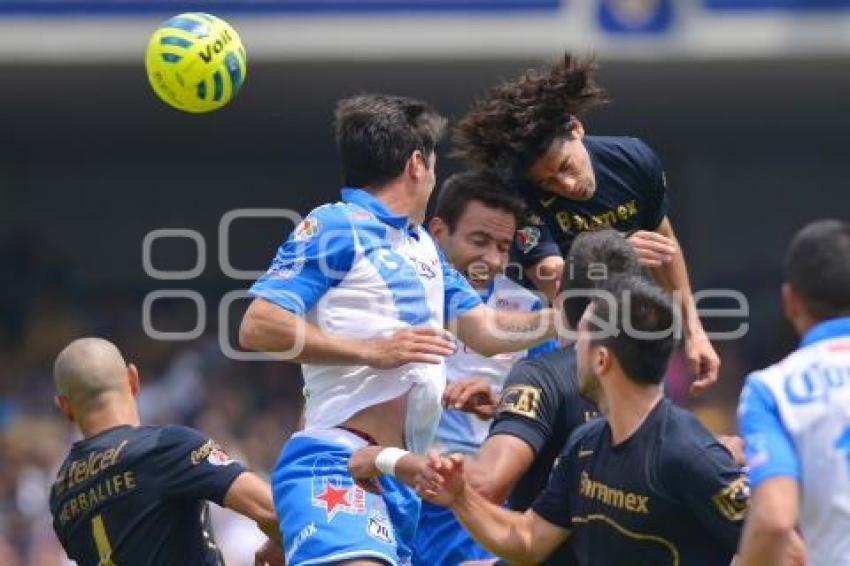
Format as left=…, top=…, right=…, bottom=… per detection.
left=414, top=501, right=493, bottom=566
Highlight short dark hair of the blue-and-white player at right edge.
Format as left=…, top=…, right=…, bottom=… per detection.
left=785, top=220, right=850, bottom=320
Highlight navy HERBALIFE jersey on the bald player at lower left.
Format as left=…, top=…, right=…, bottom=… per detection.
left=50, top=426, right=245, bottom=566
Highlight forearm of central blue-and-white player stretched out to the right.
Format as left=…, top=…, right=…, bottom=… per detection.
left=457, top=307, right=557, bottom=356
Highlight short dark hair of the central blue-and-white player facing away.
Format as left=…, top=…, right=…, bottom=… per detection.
left=335, top=94, right=446, bottom=187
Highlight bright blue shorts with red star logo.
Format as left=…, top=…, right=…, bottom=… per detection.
left=272, top=429, right=420, bottom=566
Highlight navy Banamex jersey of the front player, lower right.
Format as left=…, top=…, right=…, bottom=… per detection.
left=532, top=399, right=749, bottom=566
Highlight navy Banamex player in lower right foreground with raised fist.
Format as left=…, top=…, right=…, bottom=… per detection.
left=419, top=276, right=748, bottom=566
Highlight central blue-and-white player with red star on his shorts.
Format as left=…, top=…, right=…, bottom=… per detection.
left=240, top=94, right=555, bottom=566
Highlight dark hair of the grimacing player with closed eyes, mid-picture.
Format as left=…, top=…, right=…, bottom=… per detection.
left=434, top=169, right=525, bottom=231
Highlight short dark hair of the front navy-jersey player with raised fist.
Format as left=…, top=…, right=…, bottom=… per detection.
left=590, top=275, right=677, bottom=385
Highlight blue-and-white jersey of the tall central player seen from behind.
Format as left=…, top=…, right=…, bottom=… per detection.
left=251, top=189, right=481, bottom=452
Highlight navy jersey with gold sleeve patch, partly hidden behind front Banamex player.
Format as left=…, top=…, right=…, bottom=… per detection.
left=490, top=346, right=598, bottom=566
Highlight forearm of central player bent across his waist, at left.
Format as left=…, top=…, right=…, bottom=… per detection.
left=239, top=299, right=366, bottom=364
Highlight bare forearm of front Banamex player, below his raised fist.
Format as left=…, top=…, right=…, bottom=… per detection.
left=451, top=485, right=538, bottom=564
